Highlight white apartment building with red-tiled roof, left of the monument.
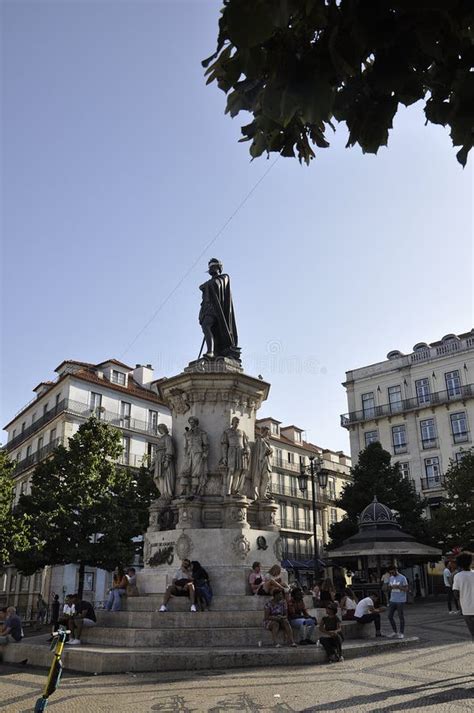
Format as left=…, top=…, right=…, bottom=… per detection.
left=0, top=359, right=171, bottom=611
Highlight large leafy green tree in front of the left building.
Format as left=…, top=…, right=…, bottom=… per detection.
left=14, top=417, right=153, bottom=589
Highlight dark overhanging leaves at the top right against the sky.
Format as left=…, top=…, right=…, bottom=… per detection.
left=203, top=0, right=474, bottom=166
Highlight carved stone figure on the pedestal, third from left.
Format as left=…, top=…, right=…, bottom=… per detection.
left=221, top=416, right=250, bottom=497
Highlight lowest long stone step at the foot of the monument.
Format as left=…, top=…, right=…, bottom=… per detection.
left=2, top=636, right=419, bottom=674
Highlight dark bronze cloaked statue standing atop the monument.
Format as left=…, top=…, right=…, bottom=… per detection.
left=199, top=258, right=240, bottom=361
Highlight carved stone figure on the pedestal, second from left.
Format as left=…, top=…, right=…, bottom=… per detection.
left=180, top=416, right=209, bottom=496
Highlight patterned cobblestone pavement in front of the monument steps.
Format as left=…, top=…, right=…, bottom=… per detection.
left=0, top=603, right=474, bottom=713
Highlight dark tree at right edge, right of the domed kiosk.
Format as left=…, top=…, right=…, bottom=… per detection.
left=433, top=450, right=474, bottom=552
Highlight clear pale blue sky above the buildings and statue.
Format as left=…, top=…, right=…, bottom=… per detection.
left=1, top=0, right=474, bottom=452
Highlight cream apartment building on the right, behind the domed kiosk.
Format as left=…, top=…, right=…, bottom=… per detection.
left=341, top=330, right=474, bottom=516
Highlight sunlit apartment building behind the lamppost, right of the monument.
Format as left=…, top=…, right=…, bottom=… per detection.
left=256, top=418, right=351, bottom=560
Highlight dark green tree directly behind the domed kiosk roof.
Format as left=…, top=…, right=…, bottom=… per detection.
left=329, top=443, right=431, bottom=547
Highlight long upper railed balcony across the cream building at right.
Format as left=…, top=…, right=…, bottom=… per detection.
left=341, top=384, right=474, bottom=428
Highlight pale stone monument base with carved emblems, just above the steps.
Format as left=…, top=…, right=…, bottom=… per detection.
left=137, top=525, right=282, bottom=595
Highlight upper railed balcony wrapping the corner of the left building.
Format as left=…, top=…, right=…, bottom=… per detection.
left=6, top=399, right=163, bottom=451
